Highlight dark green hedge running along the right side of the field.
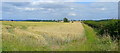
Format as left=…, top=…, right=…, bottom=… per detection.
left=83, top=19, right=120, bottom=40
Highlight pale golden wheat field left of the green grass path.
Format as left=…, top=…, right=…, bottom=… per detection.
left=2, top=21, right=84, bottom=51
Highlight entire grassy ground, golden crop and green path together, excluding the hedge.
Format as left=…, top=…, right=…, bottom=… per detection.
left=2, top=21, right=118, bottom=51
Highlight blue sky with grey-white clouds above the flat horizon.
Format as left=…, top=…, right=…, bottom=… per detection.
left=0, top=2, right=118, bottom=20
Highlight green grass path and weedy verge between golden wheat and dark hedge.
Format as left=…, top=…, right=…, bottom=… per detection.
left=51, top=24, right=118, bottom=51
